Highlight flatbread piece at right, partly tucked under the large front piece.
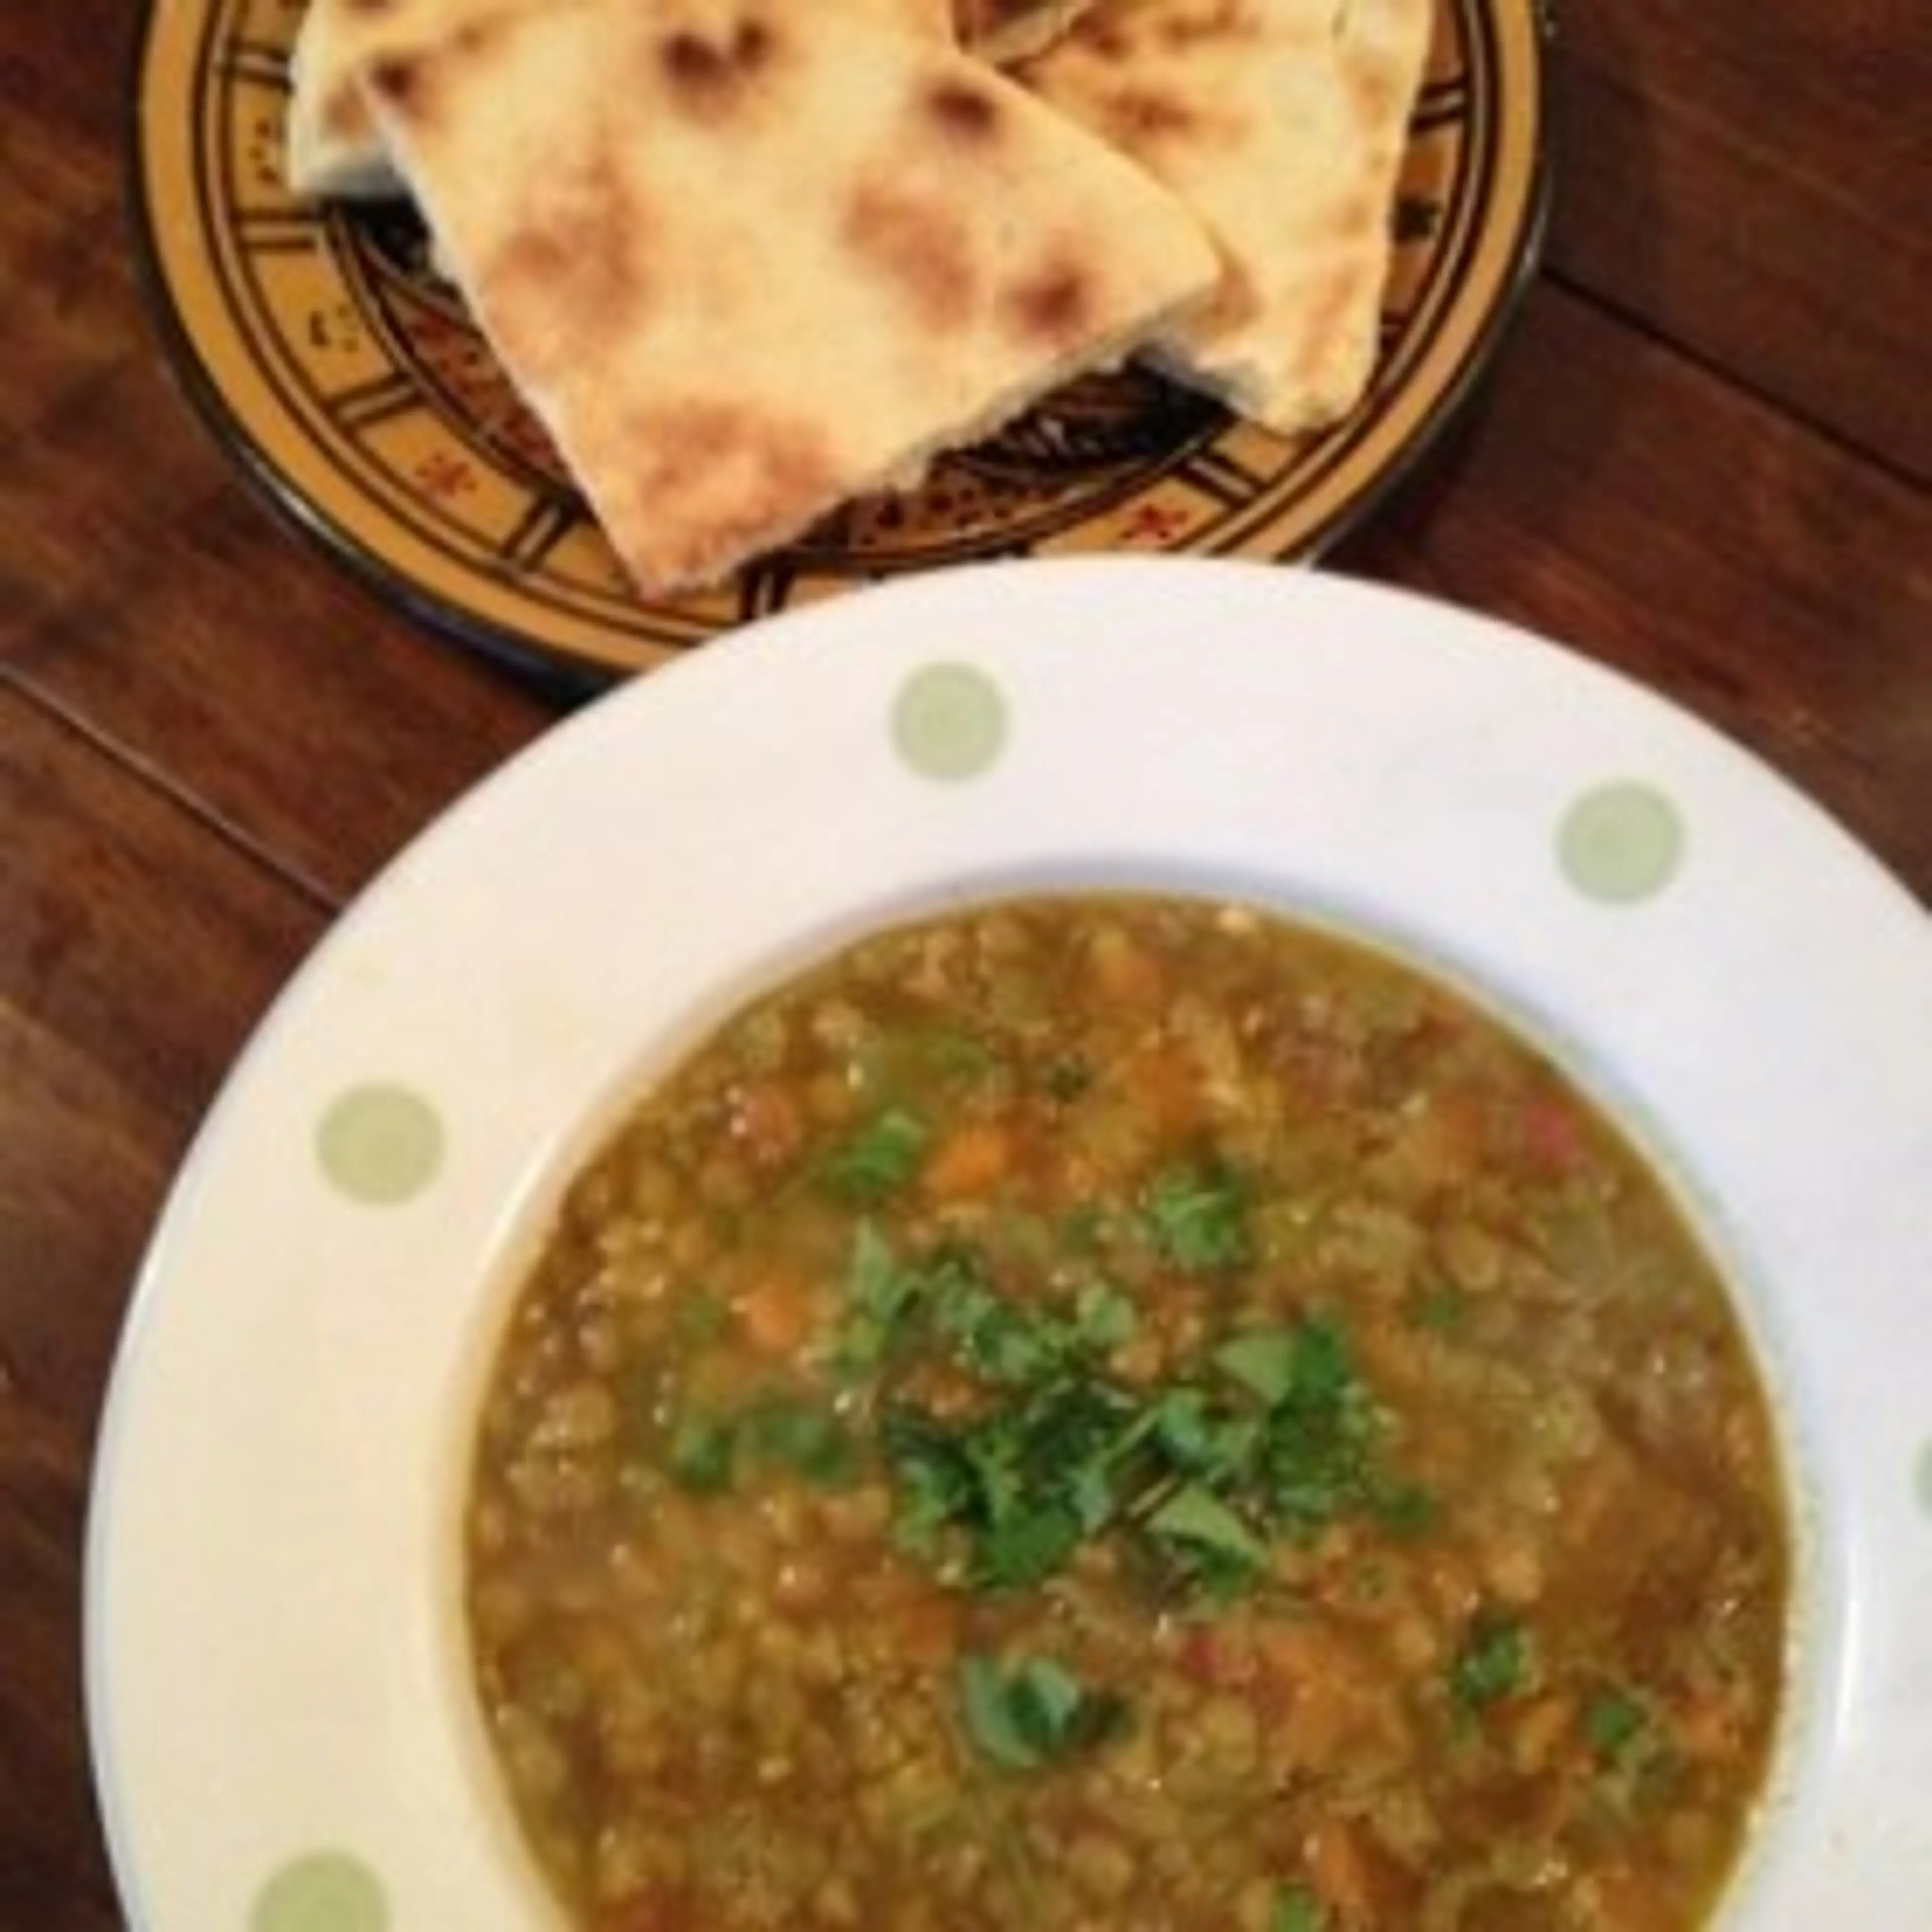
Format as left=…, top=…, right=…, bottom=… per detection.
left=1016, top=0, right=1431, bottom=435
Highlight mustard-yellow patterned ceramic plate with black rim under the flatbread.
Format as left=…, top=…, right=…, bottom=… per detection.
left=137, top=0, right=1544, bottom=672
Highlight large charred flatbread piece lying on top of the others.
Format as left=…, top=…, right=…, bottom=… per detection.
left=367, top=0, right=1219, bottom=595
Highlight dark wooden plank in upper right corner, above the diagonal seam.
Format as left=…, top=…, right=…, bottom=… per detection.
left=1550, top=0, right=1932, bottom=485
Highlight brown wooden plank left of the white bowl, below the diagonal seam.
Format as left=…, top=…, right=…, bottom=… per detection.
left=0, top=690, right=323, bottom=1928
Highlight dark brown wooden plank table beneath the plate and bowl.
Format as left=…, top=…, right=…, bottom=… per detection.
left=0, top=0, right=1932, bottom=1932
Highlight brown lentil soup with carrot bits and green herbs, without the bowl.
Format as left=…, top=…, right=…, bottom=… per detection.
left=467, top=895, right=1791, bottom=1932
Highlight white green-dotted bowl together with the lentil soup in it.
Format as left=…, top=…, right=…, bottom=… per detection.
left=89, top=560, right=1932, bottom=1932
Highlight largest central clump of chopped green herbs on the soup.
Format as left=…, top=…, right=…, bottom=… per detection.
left=831, top=1221, right=1430, bottom=1596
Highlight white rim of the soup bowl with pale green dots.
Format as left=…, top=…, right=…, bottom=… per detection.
left=87, top=558, right=1932, bottom=1932
